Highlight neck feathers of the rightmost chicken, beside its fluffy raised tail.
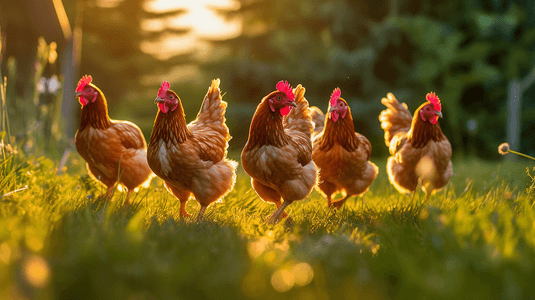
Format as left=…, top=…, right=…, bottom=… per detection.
left=407, top=102, right=446, bottom=148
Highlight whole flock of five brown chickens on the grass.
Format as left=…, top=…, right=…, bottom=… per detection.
left=75, top=75, right=452, bottom=223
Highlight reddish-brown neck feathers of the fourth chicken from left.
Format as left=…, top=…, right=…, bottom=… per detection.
left=319, top=107, right=359, bottom=151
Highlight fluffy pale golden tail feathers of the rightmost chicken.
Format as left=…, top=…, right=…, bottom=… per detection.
left=379, top=93, right=412, bottom=146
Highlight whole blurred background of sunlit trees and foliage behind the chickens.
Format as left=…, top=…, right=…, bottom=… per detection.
left=0, top=0, right=535, bottom=159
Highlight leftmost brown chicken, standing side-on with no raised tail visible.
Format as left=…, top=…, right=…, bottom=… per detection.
left=75, top=75, right=154, bottom=205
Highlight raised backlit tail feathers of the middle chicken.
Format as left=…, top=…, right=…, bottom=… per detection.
left=283, top=84, right=314, bottom=138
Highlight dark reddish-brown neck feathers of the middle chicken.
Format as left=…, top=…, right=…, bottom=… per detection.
left=245, top=99, right=290, bottom=149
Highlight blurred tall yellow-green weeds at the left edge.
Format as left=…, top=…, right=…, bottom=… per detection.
left=0, top=33, right=69, bottom=158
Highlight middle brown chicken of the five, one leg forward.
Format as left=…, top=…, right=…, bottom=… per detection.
left=241, top=81, right=317, bottom=223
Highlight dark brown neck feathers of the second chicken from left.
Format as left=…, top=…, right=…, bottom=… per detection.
left=149, top=103, right=193, bottom=144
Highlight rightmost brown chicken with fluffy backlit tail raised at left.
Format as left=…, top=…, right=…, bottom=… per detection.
left=379, top=93, right=453, bottom=199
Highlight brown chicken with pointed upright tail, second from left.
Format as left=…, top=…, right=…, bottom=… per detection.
left=147, top=79, right=238, bottom=220
